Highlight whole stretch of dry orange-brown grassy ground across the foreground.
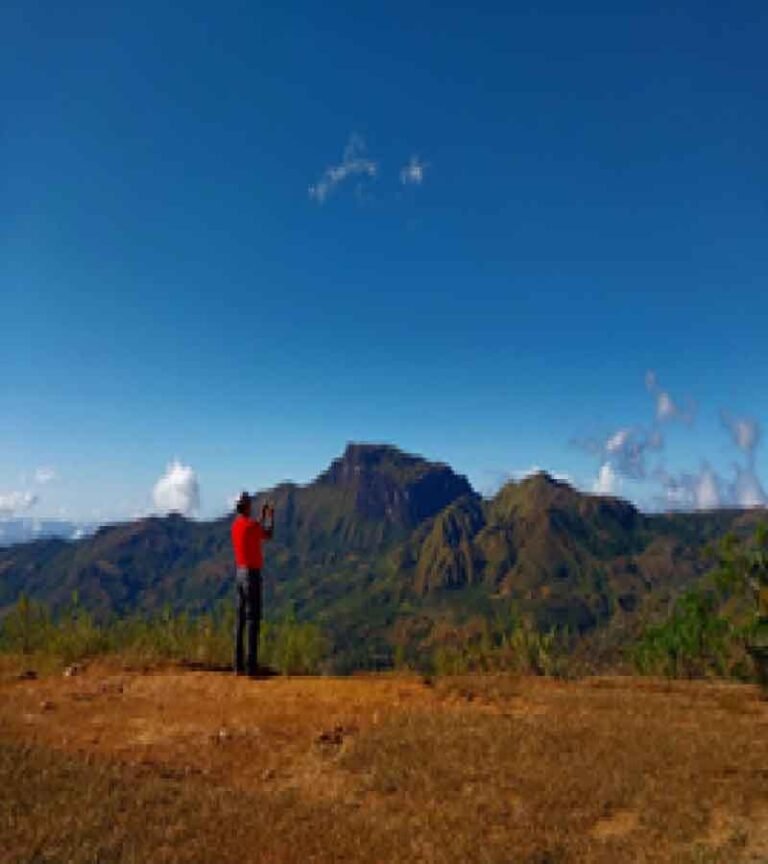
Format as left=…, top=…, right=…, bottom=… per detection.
left=0, top=663, right=768, bottom=864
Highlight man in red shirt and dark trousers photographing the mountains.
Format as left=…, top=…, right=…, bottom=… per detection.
left=232, top=492, right=275, bottom=678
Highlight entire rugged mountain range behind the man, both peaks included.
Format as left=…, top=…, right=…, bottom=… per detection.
left=0, top=444, right=761, bottom=670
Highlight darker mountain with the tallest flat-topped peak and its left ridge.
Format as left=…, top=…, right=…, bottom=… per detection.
left=0, top=444, right=474, bottom=614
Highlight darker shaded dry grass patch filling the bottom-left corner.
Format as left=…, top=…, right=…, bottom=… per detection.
left=0, top=742, right=397, bottom=864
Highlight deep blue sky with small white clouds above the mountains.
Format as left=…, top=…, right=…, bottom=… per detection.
left=0, top=2, right=768, bottom=519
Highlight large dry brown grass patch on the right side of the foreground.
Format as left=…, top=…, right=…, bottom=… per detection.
left=342, top=678, right=768, bottom=862
